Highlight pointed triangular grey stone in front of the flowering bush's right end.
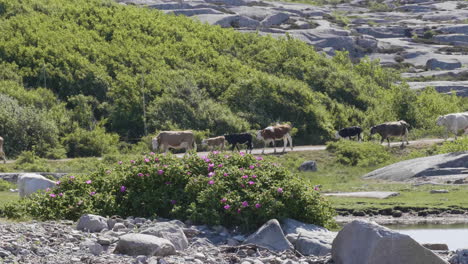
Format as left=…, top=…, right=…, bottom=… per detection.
left=243, top=219, right=293, bottom=251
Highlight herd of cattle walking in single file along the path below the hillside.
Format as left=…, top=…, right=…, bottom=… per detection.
left=0, top=112, right=468, bottom=163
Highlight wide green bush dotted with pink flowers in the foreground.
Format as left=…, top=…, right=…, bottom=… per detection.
left=4, top=152, right=334, bottom=229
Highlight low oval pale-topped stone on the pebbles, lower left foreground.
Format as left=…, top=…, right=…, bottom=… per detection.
left=114, top=234, right=176, bottom=257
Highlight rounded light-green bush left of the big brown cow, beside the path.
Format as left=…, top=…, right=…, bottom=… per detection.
left=63, top=126, right=119, bottom=157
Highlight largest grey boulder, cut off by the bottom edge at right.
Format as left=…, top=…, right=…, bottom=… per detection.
left=332, top=220, right=446, bottom=264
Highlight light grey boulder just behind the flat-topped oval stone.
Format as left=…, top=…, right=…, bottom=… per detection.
left=141, top=222, right=188, bottom=250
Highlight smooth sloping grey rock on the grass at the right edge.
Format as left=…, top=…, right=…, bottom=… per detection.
left=363, top=152, right=468, bottom=181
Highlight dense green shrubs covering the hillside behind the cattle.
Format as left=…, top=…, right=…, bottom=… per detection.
left=0, top=0, right=468, bottom=158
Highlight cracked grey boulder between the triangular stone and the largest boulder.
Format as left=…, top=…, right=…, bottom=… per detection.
left=282, top=218, right=336, bottom=256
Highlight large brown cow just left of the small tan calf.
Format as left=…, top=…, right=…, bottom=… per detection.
left=152, top=131, right=197, bottom=153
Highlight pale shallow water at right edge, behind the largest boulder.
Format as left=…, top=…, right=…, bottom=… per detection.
left=387, top=224, right=468, bottom=250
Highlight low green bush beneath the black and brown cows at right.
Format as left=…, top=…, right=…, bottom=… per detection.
left=327, top=139, right=392, bottom=167
